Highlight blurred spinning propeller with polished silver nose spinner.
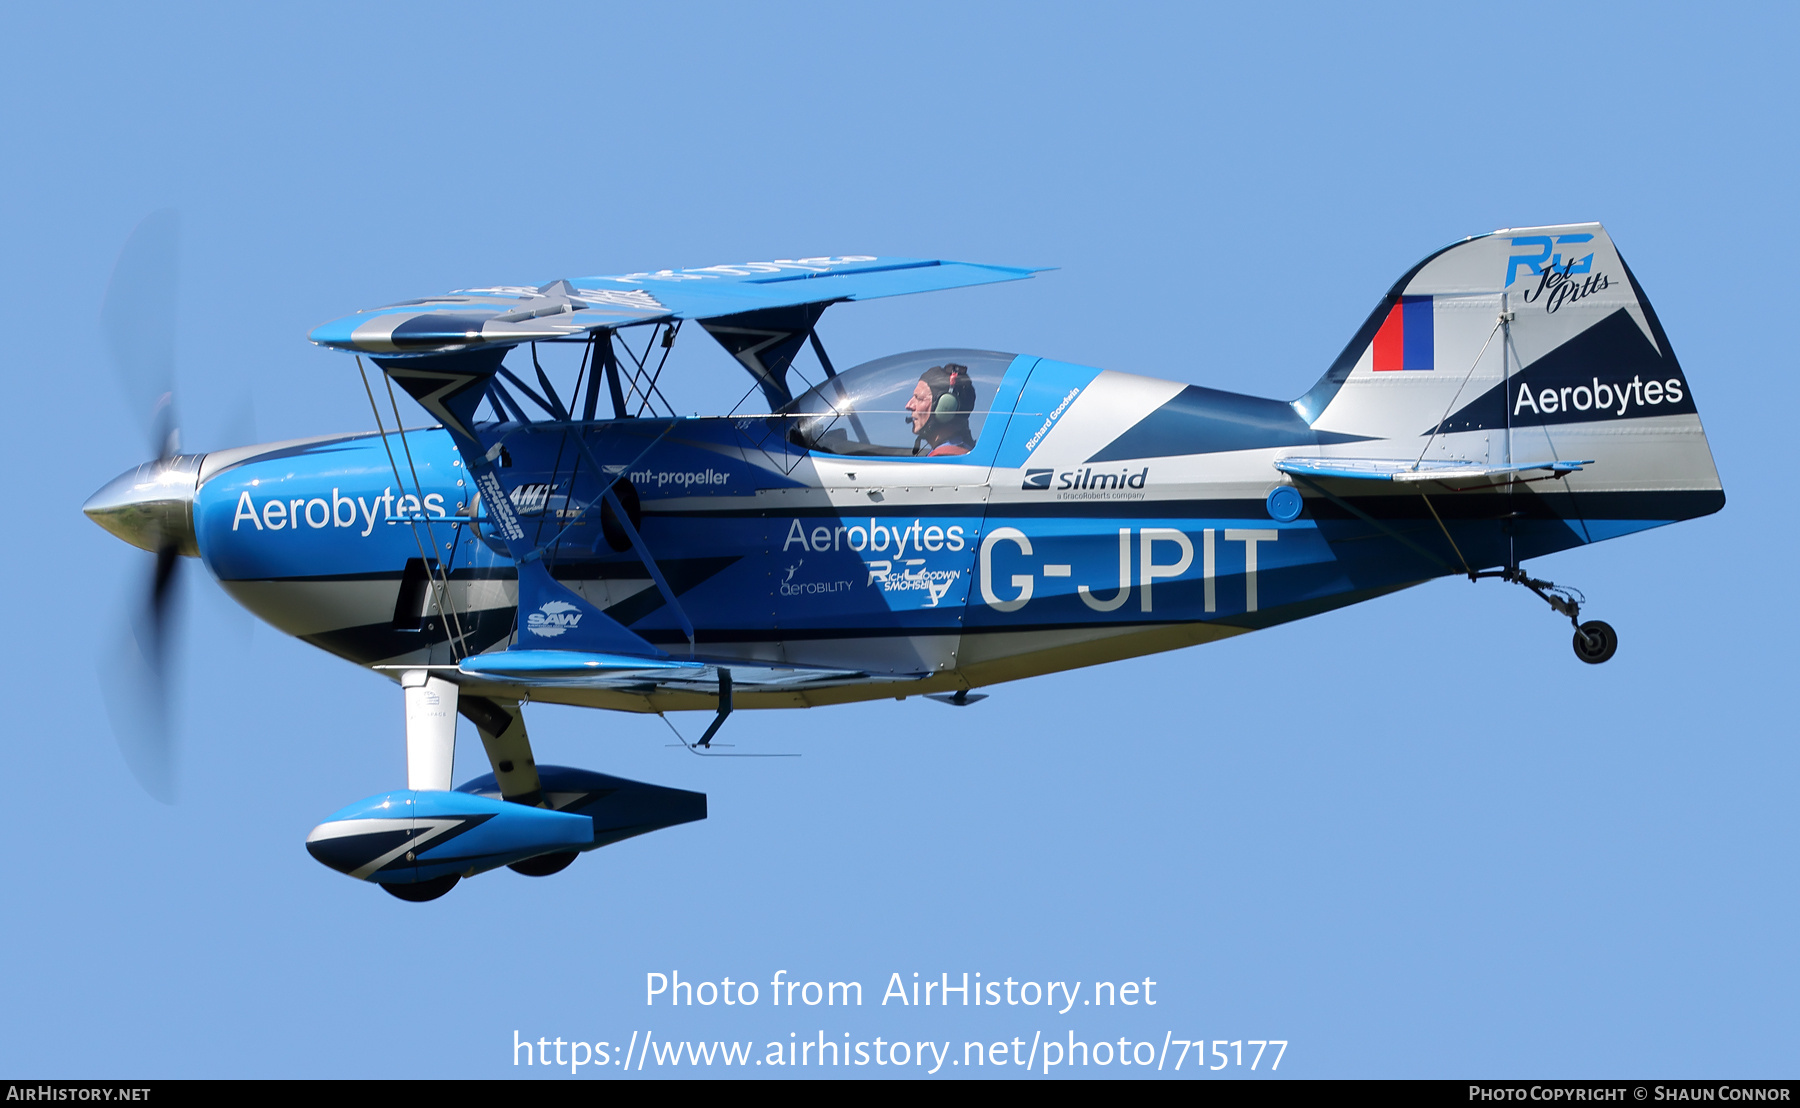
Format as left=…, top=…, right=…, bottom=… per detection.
left=83, top=209, right=190, bottom=804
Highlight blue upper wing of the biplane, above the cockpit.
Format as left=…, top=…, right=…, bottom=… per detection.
left=308, top=255, right=1042, bottom=358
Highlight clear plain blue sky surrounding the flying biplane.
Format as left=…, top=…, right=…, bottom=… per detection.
left=0, top=4, right=1800, bottom=1077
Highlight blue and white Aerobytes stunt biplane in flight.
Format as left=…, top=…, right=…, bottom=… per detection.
left=85, top=223, right=1724, bottom=899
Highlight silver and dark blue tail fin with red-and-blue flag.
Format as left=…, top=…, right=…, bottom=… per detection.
left=1294, top=223, right=1724, bottom=541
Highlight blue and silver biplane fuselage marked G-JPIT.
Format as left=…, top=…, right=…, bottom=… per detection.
left=147, top=351, right=1723, bottom=710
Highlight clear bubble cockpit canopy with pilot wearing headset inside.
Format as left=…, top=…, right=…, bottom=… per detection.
left=779, top=349, right=1013, bottom=457
